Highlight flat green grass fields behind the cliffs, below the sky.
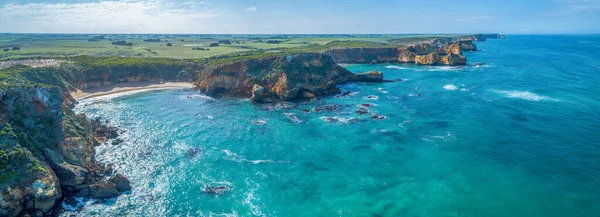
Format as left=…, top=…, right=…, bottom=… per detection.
left=0, top=33, right=468, bottom=60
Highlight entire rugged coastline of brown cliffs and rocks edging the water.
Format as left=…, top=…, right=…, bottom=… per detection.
left=0, top=34, right=504, bottom=216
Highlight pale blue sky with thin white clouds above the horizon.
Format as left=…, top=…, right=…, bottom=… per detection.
left=0, top=0, right=600, bottom=34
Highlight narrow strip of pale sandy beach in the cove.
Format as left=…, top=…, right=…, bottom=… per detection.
left=71, top=82, right=195, bottom=100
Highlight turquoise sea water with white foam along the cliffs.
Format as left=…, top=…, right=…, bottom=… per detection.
left=71, top=35, right=600, bottom=217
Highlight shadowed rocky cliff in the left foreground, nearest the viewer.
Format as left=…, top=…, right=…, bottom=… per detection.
left=0, top=87, right=129, bottom=216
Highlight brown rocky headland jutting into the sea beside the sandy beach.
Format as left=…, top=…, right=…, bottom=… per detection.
left=197, top=53, right=383, bottom=101
